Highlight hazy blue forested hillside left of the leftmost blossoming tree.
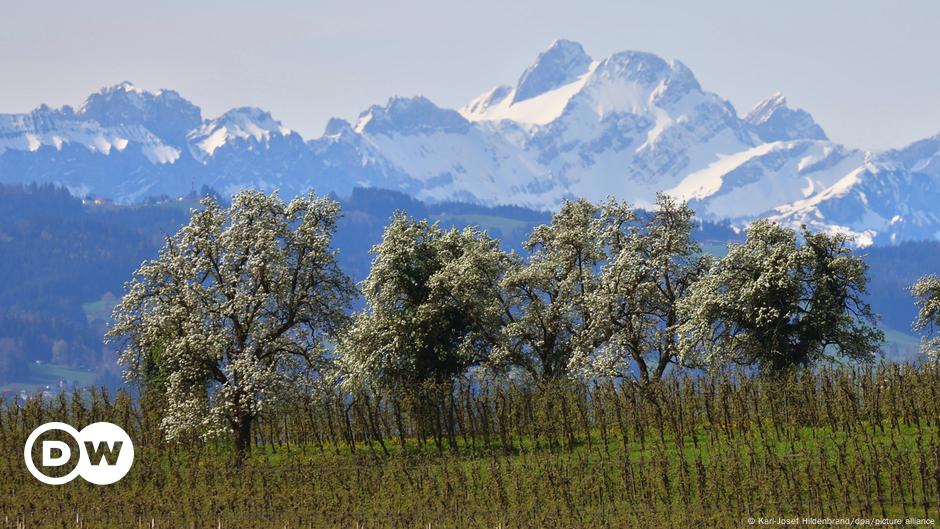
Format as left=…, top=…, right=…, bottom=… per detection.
left=0, top=185, right=187, bottom=381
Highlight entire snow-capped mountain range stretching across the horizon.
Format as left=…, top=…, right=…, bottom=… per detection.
left=0, top=40, right=940, bottom=246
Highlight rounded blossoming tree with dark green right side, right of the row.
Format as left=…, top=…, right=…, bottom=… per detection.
left=679, top=220, right=884, bottom=370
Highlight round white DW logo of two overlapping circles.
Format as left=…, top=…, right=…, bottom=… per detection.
left=23, top=422, right=134, bottom=485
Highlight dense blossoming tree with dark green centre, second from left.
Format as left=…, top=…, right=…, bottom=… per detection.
left=340, top=214, right=513, bottom=387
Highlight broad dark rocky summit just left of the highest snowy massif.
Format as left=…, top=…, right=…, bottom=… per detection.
left=355, top=96, right=470, bottom=136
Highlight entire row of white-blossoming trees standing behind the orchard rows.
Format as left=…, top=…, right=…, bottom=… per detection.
left=103, top=191, right=896, bottom=462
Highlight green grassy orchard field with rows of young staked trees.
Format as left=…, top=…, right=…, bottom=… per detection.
left=0, top=364, right=940, bottom=528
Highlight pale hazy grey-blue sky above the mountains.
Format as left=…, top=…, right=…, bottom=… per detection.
left=0, top=0, right=940, bottom=148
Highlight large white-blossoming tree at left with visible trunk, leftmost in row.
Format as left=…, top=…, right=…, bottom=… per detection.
left=108, top=191, right=354, bottom=454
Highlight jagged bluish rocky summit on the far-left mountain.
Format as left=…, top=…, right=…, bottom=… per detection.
left=78, top=81, right=202, bottom=146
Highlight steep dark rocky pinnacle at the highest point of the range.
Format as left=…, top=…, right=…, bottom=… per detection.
left=512, top=39, right=591, bottom=103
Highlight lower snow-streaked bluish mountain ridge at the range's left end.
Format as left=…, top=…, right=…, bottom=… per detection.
left=0, top=82, right=343, bottom=202
